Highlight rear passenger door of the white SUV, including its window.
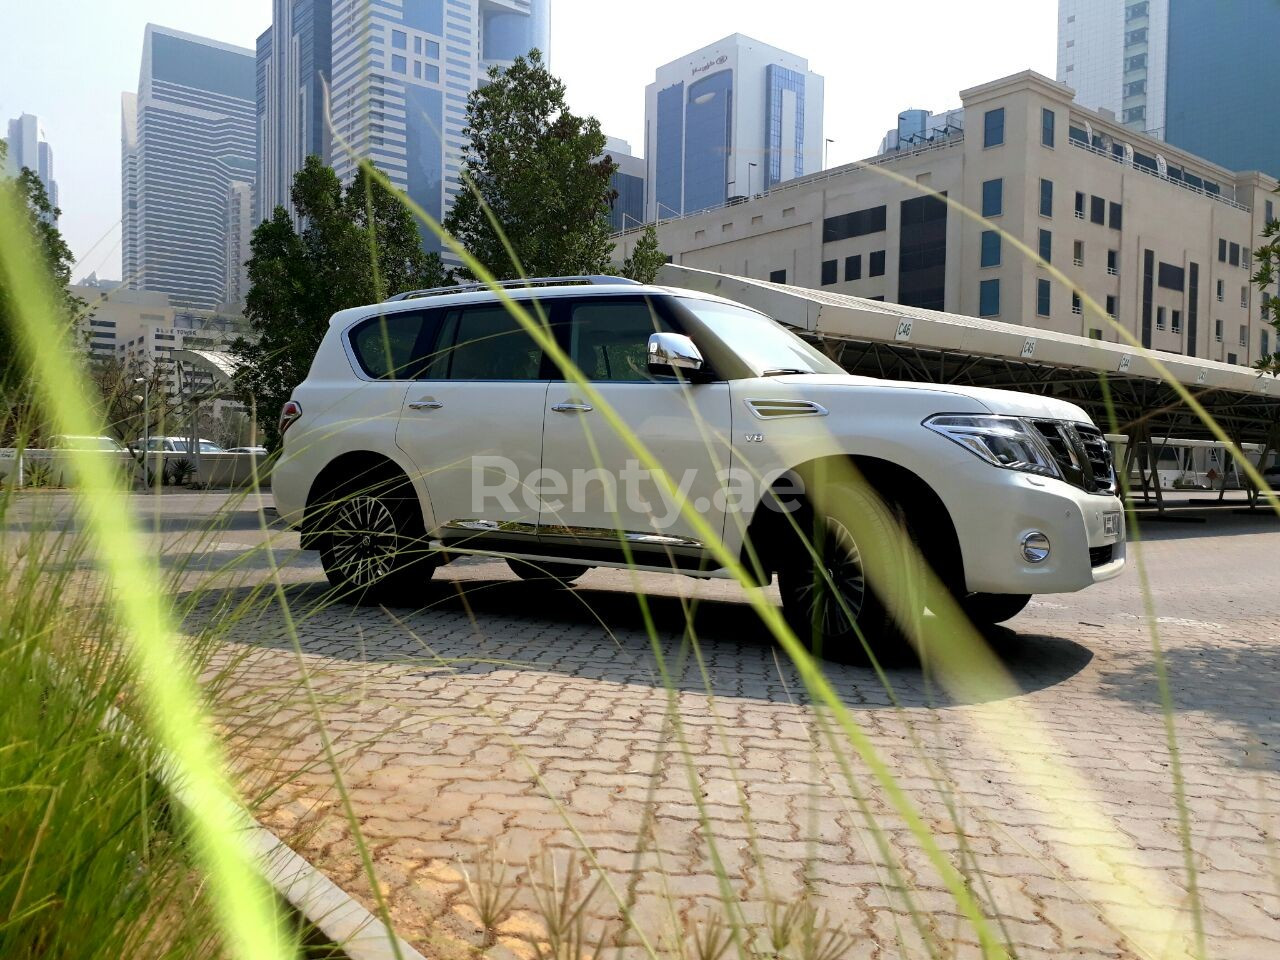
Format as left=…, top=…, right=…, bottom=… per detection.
left=396, top=303, right=549, bottom=548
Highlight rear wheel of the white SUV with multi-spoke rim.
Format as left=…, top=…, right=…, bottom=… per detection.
left=316, top=475, right=439, bottom=604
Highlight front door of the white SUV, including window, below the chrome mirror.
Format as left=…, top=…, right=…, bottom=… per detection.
left=539, top=296, right=732, bottom=562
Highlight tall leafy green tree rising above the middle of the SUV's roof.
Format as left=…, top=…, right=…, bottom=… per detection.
left=444, top=50, right=616, bottom=280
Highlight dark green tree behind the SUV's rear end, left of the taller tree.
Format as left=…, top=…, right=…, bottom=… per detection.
left=232, top=156, right=447, bottom=445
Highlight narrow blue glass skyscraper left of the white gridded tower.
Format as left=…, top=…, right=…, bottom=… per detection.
left=256, top=0, right=333, bottom=220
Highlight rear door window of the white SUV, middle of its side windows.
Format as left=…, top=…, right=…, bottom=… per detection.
left=426, top=303, right=544, bottom=380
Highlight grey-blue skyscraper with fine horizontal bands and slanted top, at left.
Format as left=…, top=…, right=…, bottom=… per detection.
left=122, top=24, right=257, bottom=308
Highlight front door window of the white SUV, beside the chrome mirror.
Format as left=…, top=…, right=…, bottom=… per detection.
left=570, top=298, right=673, bottom=381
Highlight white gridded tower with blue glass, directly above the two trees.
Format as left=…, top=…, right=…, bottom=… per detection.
left=330, top=0, right=549, bottom=250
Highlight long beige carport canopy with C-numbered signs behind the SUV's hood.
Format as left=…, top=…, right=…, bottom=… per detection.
left=659, top=264, right=1280, bottom=500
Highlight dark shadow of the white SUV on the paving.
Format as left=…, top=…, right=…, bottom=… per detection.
left=186, top=575, right=1093, bottom=708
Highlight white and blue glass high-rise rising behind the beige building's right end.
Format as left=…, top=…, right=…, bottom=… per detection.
left=1057, top=0, right=1280, bottom=175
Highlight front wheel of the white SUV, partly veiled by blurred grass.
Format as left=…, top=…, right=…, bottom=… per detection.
left=778, top=483, right=923, bottom=663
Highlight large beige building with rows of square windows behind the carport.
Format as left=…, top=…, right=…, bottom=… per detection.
left=617, top=72, right=1280, bottom=364
